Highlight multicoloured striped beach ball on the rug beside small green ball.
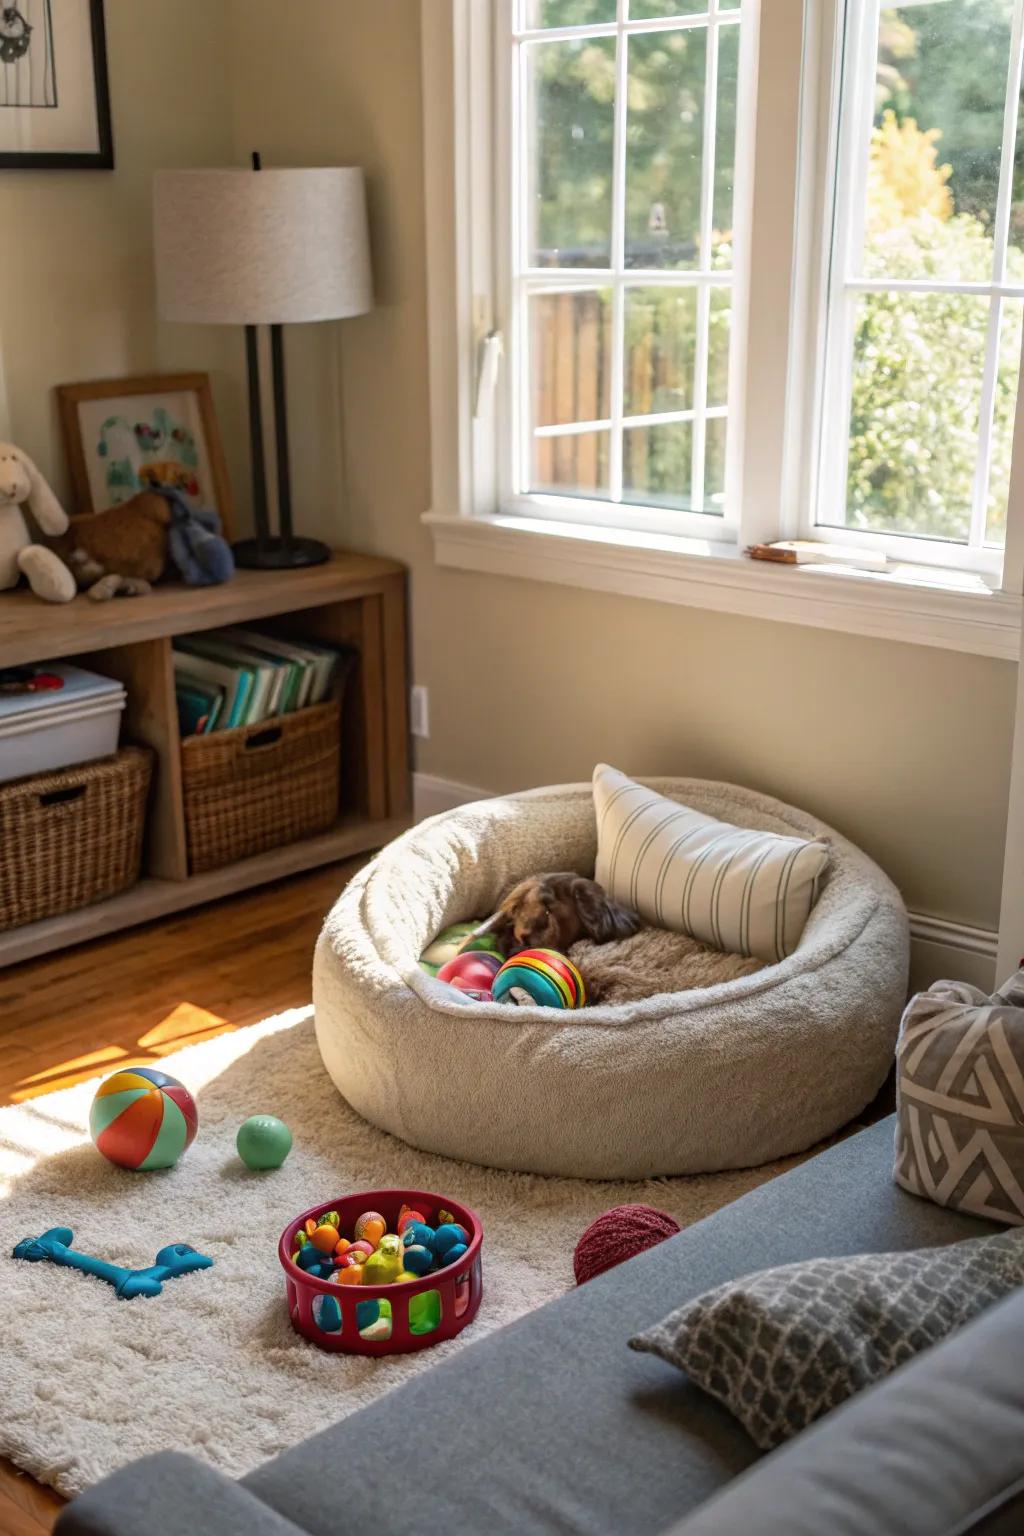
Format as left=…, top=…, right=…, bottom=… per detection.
left=89, top=1066, right=200, bottom=1170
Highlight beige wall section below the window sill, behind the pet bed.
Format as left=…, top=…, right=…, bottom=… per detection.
left=418, top=573, right=1013, bottom=926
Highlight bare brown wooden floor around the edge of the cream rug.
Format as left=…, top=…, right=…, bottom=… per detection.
left=0, top=860, right=362, bottom=1536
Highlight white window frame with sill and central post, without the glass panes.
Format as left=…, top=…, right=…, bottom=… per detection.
left=421, top=0, right=1024, bottom=659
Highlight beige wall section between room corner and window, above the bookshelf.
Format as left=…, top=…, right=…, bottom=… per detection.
left=227, top=0, right=430, bottom=564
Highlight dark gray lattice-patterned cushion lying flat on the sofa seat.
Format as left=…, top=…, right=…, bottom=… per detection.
left=629, top=1232, right=1024, bottom=1450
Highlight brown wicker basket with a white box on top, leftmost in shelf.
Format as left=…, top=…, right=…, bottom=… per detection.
left=0, top=746, right=154, bottom=929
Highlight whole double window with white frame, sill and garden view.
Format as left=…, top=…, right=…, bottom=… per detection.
left=422, top=0, right=1024, bottom=657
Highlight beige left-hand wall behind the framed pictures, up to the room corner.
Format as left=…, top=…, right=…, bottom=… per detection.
left=0, top=0, right=244, bottom=516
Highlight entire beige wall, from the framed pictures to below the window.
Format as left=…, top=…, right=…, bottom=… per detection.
left=0, top=0, right=1013, bottom=926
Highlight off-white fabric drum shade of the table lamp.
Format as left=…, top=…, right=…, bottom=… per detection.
left=154, top=167, right=373, bottom=326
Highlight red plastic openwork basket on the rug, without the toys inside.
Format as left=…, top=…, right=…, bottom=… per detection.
left=278, top=1189, right=484, bottom=1355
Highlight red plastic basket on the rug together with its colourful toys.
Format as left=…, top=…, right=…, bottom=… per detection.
left=278, top=1189, right=484, bottom=1355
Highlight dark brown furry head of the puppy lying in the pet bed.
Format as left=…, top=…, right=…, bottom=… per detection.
left=476, top=871, right=640, bottom=958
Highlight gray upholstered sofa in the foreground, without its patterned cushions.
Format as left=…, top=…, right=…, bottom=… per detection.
left=57, top=1120, right=1024, bottom=1536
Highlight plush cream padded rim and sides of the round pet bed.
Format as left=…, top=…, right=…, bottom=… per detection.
left=313, top=779, right=907, bottom=1178
